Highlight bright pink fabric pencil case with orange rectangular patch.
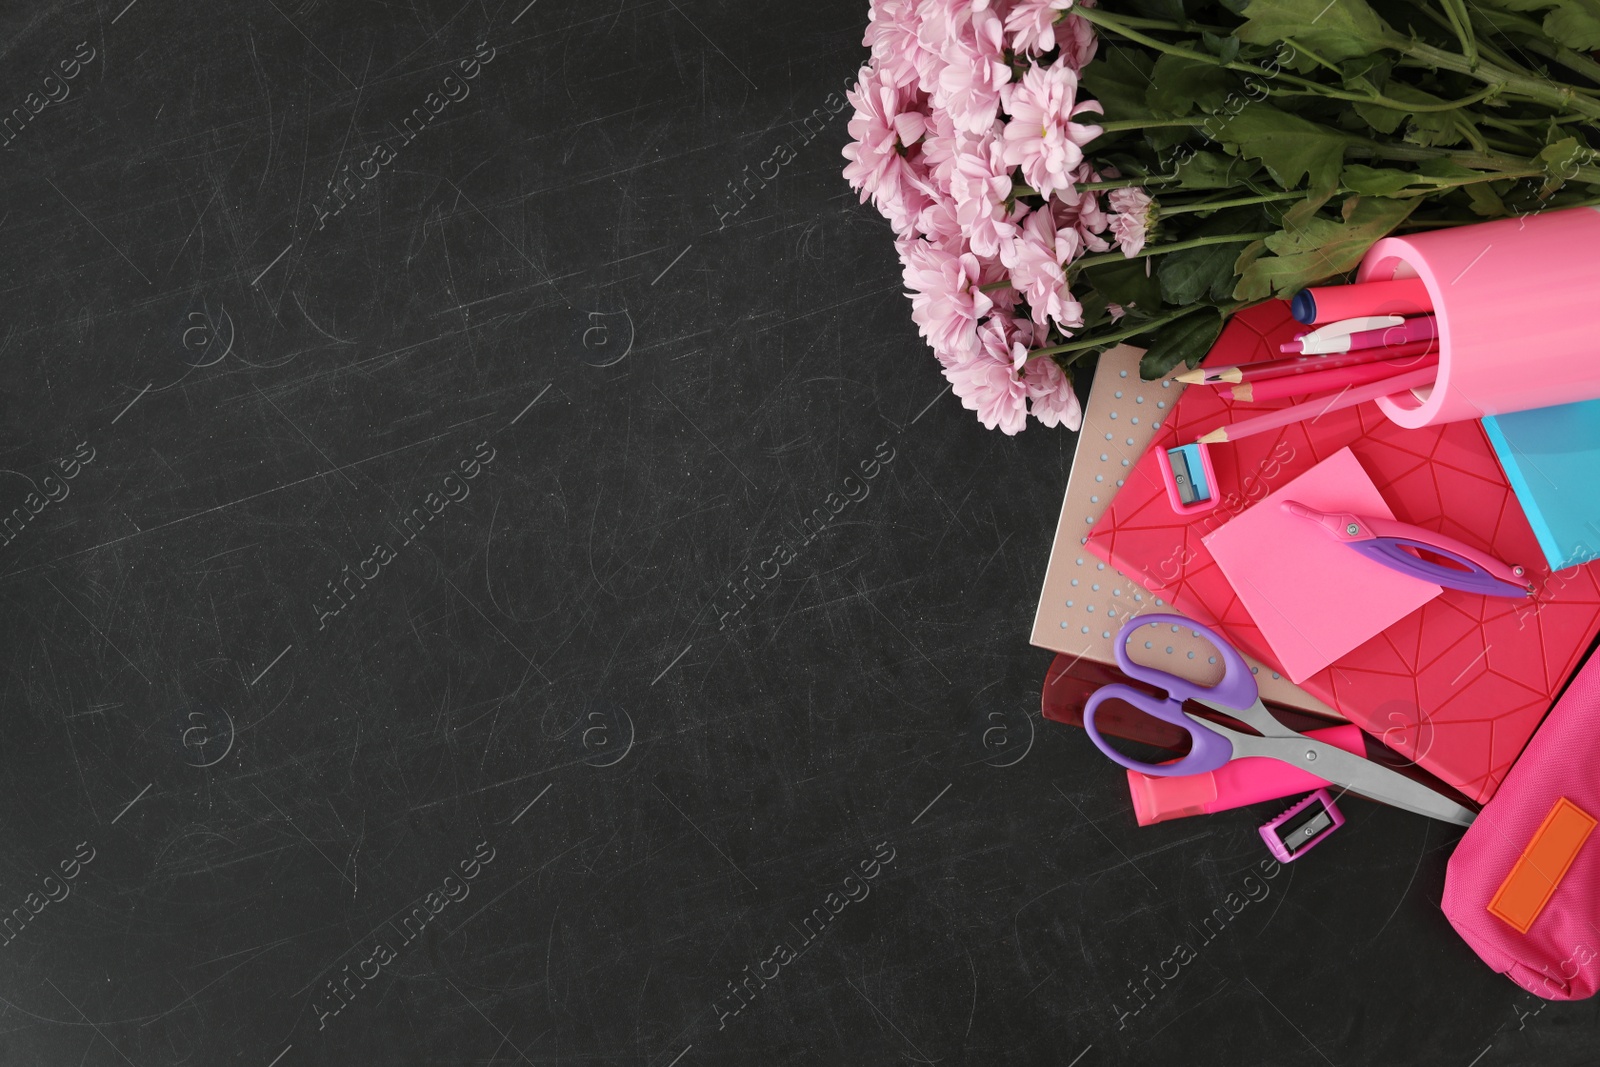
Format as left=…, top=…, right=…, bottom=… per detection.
left=1443, top=643, right=1600, bottom=1000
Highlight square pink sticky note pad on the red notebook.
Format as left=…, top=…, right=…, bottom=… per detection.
left=1203, top=448, right=1443, bottom=683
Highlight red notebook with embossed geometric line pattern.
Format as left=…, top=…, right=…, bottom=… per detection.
left=1085, top=301, right=1600, bottom=801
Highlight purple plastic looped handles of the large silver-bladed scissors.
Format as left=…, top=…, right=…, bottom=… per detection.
left=1083, top=614, right=1277, bottom=777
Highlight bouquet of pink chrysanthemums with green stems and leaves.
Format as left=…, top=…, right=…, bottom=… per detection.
left=845, top=0, right=1600, bottom=434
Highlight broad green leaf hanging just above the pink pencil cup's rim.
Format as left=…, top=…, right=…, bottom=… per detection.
left=1234, top=197, right=1421, bottom=299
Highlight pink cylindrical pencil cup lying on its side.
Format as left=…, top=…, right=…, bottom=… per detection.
left=1357, top=208, right=1600, bottom=429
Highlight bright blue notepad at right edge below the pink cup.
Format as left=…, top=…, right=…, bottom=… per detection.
left=1483, top=400, right=1600, bottom=571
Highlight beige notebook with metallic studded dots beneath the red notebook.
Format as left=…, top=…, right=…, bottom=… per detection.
left=1030, top=344, right=1344, bottom=720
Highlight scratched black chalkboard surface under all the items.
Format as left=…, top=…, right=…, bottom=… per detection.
left=0, top=0, right=1597, bottom=1067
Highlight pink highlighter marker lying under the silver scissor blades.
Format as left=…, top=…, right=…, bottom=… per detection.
left=1128, top=723, right=1366, bottom=825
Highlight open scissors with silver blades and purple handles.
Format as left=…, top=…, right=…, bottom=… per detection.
left=1083, top=614, right=1477, bottom=825
